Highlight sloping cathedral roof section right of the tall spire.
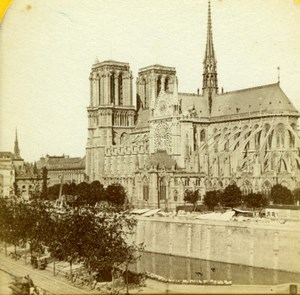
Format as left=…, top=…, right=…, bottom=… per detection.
left=211, top=83, right=298, bottom=117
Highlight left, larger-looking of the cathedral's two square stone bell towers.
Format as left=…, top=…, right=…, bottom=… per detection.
left=86, top=60, right=135, bottom=181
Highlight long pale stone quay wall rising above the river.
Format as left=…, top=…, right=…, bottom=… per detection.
left=132, top=216, right=300, bottom=273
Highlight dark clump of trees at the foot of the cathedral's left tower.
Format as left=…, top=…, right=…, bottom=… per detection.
left=44, top=180, right=127, bottom=206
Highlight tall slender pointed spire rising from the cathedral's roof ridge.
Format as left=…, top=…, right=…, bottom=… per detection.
left=202, top=0, right=218, bottom=111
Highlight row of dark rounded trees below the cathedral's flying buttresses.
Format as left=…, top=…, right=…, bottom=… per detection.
left=184, top=184, right=300, bottom=210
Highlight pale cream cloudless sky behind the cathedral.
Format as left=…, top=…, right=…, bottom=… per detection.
left=0, top=0, right=300, bottom=162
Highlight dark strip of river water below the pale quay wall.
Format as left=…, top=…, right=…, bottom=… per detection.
left=133, top=252, right=300, bottom=285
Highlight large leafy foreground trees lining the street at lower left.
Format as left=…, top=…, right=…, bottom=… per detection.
left=0, top=198, right=142, bottom=290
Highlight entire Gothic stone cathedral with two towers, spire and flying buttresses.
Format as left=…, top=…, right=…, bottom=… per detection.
left=86, top=3, right=300, bottom=210
